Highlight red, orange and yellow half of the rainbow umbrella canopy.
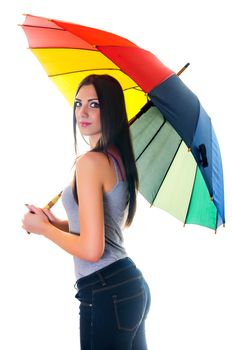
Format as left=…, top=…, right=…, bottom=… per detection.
left=22, top=15, right=174, bottom=119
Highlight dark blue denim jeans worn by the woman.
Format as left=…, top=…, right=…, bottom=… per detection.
left=75, top=257, right=150, bottom=350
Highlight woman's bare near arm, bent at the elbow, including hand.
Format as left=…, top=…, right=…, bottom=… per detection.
left=23, top=153, right=105, bottom=261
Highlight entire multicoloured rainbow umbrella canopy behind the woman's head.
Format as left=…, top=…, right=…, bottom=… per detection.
left=22, top=15, right=225, bottom=230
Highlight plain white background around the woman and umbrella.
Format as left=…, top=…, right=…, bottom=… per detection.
left=0, top=0, right=232, bottom=350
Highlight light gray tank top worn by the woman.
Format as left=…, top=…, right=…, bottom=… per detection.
left=62, top=152, right=129, bottom=280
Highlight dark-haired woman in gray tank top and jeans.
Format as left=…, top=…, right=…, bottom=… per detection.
left=23, top=75, right=150, bottom=350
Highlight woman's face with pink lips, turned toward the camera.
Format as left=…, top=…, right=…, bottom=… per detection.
left=75, top=85, right=101, bottom=145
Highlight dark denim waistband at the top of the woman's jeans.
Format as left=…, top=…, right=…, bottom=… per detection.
left=74, top=257, right=136, bottom=290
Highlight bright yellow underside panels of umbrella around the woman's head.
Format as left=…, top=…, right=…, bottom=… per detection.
left=32, top=48, right=147, bottom=120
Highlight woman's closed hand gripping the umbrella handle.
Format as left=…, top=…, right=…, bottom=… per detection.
left=22, top=205, right=50, bottom=234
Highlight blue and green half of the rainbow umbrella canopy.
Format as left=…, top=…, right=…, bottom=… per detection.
left=130, top=74, right=225, bottom=230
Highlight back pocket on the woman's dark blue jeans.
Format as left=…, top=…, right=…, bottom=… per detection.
left=112, top=290, right=145, bottom=331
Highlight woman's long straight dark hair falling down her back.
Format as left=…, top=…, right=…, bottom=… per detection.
left=73, top=74, right=139, bottom=226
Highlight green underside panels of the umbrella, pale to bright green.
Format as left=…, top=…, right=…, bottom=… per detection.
left=130, top=107, right=217, bottom=229
